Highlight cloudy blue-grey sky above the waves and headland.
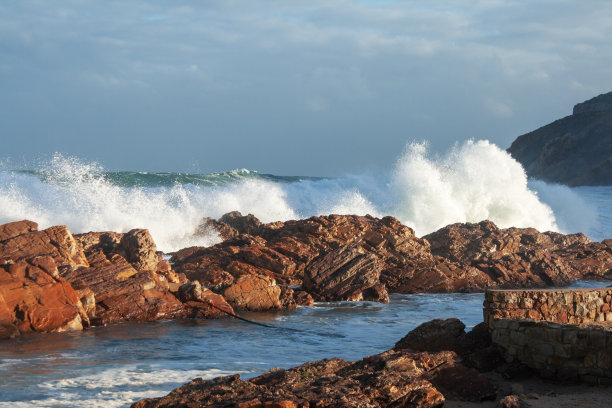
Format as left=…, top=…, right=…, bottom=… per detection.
left=0, top=0, right=612, bottom=176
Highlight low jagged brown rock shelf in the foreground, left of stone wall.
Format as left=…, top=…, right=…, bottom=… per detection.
left=132, top=320, right=496, bottom=408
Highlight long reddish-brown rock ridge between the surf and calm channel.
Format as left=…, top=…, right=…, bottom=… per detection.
left=0, top=212, right=612, bottom=338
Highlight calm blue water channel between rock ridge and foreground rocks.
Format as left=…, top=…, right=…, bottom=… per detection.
left=0, top=282, right=609, bottom=408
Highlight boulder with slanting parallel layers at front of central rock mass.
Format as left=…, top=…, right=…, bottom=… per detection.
left=304, top=245, right=389, bottom=302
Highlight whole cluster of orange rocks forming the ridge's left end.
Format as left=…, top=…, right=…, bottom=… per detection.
left=0, top=221, right=233, bottom=338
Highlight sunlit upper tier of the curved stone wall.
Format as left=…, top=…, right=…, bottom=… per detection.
left=484, top=288, right=612, bottom=324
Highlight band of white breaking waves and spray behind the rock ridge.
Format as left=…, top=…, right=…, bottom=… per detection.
left=0, top=141, right=610, bottom=252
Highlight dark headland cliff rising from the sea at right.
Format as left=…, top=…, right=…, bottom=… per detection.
left=508, top=92, right=612, bottom=186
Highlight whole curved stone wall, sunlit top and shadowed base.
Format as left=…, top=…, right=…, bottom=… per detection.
left=484, top=288, right=612, bottom=385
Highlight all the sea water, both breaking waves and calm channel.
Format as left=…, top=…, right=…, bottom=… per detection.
left=0, top=141, right=612, bottom=408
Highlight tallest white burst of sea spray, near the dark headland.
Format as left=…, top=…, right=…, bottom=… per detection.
left=389, top=141, right=558, bottom=235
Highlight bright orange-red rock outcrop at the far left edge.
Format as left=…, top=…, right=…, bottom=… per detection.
left=0, top=221, right=89, bottom=338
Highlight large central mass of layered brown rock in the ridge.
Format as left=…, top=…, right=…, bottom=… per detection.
left=172, top=213, right=434, bottom=308
